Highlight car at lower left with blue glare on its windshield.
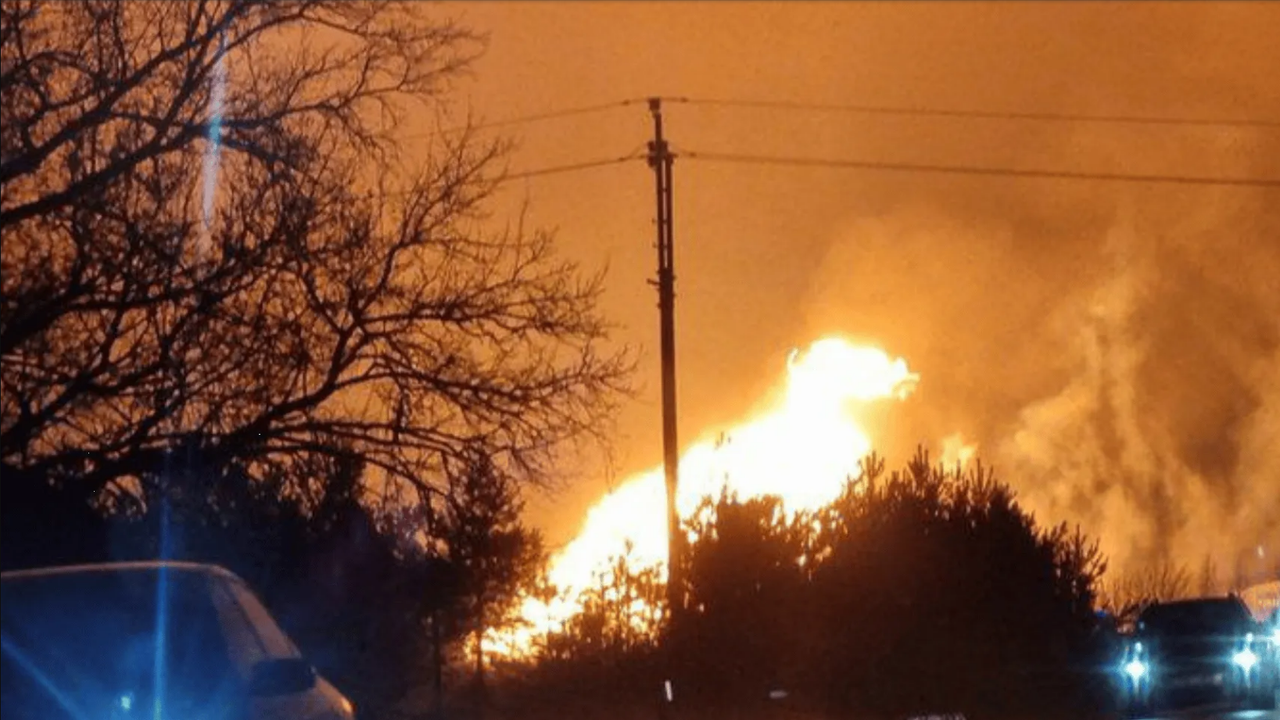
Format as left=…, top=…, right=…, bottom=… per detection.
left=0, top=561, right=355, bottom=720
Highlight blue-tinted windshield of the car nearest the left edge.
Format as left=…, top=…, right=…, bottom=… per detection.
left=0, top=570, right=234, bottom=716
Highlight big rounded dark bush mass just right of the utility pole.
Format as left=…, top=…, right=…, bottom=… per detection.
left=670, top=451, right=1105, bottom=714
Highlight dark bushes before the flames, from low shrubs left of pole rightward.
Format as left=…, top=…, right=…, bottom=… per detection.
left=504, top=452, right=1108, bottom=717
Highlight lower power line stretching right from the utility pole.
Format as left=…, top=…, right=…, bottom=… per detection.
left=681, top=151, right=1280, bottom=187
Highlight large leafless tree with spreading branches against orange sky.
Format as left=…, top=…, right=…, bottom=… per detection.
left=0, top=0, right=627, bottom=504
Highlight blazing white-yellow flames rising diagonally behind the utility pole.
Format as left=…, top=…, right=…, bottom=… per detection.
left=486, top=337, right=919, bottom=655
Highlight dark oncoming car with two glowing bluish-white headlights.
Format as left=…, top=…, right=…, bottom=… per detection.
left=1117, top=596, right=1280, bottom=716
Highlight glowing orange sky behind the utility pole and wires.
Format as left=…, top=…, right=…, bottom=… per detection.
left=429, top=1, right=1280, bottom=571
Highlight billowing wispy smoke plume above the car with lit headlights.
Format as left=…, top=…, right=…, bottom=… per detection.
left=996, top=213, right=1280, bottom=580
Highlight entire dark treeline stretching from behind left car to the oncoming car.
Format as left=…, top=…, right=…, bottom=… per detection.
left=3, top=440, right=1126, bottom=720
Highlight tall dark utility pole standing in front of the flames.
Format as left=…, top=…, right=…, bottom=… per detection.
left=649, top=97, right=685, bottom=625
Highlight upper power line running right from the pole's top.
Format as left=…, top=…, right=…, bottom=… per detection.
left=663, top=97, right=1280, bottom=129
